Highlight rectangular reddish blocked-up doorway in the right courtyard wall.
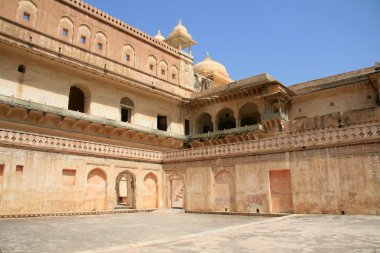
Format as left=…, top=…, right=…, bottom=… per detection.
left=269, top=170, right=293, bottom=213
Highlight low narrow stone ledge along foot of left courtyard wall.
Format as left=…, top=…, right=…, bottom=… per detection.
left=0, top=209, right=157, bottom=219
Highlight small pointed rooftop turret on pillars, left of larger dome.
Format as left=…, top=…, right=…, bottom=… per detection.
left=164, top=19, right=197, bottom=54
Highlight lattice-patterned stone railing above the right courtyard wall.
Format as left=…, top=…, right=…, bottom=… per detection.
left=163, top=123, right=380, bottom=162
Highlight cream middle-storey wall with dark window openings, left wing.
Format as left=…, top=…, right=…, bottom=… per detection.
left=0, top=45, right=183, bottom=134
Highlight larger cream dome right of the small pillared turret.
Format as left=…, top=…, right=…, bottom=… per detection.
left=194, top=52, right=233, bottom=85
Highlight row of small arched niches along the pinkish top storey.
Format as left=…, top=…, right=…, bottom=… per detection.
left=16, top=0, right=178, bottom=83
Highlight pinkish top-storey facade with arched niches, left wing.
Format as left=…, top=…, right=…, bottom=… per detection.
left=0, top=0, right=193, bottom=95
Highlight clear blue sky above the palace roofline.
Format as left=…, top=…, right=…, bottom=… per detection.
left=86, top=0, right=380, bottom=85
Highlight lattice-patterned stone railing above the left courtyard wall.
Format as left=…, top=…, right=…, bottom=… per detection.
left=0, top=129, right=162, bottom=162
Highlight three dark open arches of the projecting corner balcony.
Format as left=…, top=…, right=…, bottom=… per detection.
left=195, top=102, right=261, bottom=133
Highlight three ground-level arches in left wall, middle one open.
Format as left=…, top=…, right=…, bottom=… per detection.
left=85, top=168, right=158, bottom=210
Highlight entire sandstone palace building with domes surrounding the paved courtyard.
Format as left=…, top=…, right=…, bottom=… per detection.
left=0, top=0, right=380, bottom=215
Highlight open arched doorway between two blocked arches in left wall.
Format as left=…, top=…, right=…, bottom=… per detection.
left=116, top=171, right=136, bottom=208
